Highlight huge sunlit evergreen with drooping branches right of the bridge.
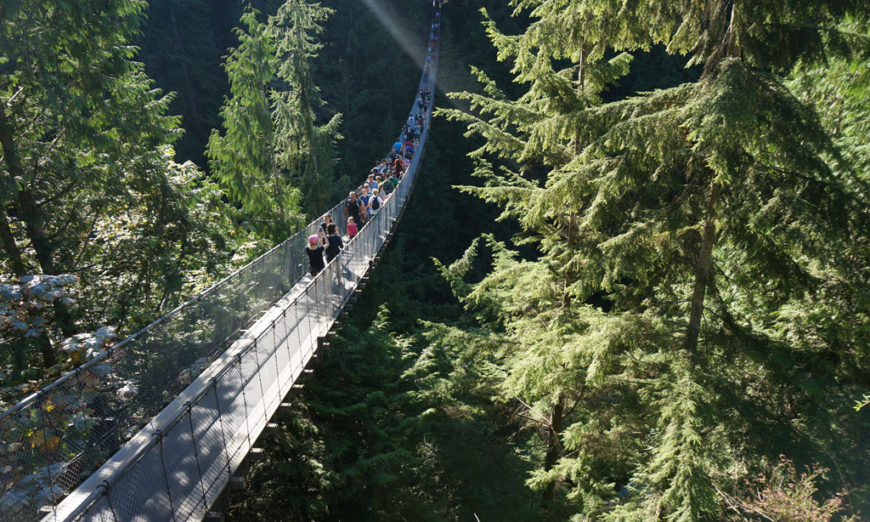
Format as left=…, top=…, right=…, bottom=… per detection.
left=445, top=0, right=868, bottom=520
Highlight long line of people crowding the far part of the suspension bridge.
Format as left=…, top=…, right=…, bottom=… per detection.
left=305, top=9, right=441, bottom=276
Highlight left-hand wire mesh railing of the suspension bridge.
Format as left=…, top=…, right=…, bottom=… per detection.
left=0, top=178, right=340, bottom=520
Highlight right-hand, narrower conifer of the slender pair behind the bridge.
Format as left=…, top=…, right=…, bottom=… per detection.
left=269, top=0, right=341, bottom=215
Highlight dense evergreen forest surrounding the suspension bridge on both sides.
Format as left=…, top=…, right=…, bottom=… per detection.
left=0, top=0, right=870, bottom=520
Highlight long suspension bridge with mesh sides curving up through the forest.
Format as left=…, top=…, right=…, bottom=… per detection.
left=0, top=11, right=440, bottom=521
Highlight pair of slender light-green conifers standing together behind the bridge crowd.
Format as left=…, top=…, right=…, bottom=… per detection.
left=207, top=0, right=341, bottom=238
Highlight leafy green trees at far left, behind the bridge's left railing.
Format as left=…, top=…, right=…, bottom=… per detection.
left=0, top=1, right=232, bottom=374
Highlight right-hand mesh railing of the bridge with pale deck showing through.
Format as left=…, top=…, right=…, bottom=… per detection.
left=56, top=120, right=430, bottom=521
